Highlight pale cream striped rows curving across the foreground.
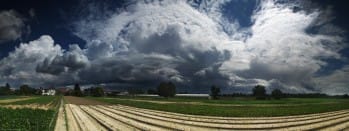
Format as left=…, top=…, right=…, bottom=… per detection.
left=66, top=104, right=349, bottom=130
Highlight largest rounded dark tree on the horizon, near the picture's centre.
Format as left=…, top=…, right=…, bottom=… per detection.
left=157, top=82, right=176, bottom=97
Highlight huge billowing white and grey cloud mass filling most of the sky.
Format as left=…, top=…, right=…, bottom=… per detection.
left=0, top=1, right=344, bottom=92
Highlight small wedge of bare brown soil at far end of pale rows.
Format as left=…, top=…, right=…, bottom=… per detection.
left=64, top=96, right=107, bottom=105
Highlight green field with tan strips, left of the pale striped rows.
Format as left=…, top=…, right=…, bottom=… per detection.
left=0, top=96, right=60, bottom=130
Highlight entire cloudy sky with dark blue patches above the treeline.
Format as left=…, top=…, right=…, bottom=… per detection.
left=0, top=0, right=349, bottom=95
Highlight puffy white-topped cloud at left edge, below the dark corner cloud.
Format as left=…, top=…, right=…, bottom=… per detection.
left=0, top=35, right=63, bottom=86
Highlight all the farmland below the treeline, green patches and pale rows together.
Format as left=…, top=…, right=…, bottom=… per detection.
left=0, top=96, right=349, bottom=131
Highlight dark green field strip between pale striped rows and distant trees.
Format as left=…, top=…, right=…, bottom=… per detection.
left=88, top=97, right=349, bottom=117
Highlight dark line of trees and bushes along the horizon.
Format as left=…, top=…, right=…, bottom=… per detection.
left=0, top=82, right=349, bottom=99
